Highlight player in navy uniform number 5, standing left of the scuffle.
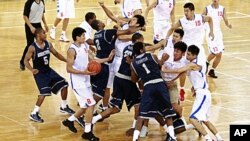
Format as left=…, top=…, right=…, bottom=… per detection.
left=24, top=28, right=75, bottom=122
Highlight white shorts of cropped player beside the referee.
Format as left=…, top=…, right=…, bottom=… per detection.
left=57, top=0, right=75, bottom=19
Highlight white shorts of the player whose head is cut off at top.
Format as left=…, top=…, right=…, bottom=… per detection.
left=154, top=21, right=170, bottom=41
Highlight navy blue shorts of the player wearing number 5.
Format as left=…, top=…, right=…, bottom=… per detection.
left=34, top=69, right=68, bottom=96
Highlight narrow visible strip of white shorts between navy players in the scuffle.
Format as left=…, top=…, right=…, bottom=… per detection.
left=107, top=57, right=121, bottom=88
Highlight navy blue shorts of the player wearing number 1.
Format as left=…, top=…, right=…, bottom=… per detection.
left=139, top=82, right=176, bottom=118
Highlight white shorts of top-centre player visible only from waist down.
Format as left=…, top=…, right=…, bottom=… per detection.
left=121, top=0, right=142, bottom=18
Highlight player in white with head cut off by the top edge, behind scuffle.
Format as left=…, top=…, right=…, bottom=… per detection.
left=144, top=0, right=175, bottom=44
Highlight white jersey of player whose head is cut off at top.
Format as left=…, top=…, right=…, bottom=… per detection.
left=153, top=0, right=175, bottom=21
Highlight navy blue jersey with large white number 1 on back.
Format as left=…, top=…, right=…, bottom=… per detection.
left=132, top=53, right=162, bottom=83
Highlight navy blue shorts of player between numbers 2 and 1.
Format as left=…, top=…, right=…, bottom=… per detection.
left=110, top=76, right=141, bottom=111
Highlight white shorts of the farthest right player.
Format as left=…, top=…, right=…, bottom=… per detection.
left=206, top=31, right=224, bottom=54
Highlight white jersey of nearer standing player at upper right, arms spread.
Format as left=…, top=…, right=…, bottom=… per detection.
left=179, top=14, right=204, bottom=48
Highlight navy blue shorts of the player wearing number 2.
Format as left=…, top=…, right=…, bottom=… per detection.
left=90, top=64, right=109, bottom=98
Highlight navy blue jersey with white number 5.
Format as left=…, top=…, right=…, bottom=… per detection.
left=32, top=41, right=50, bottom=72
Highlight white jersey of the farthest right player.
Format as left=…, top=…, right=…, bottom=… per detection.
left=206, top=5, right=224, bottom=33
